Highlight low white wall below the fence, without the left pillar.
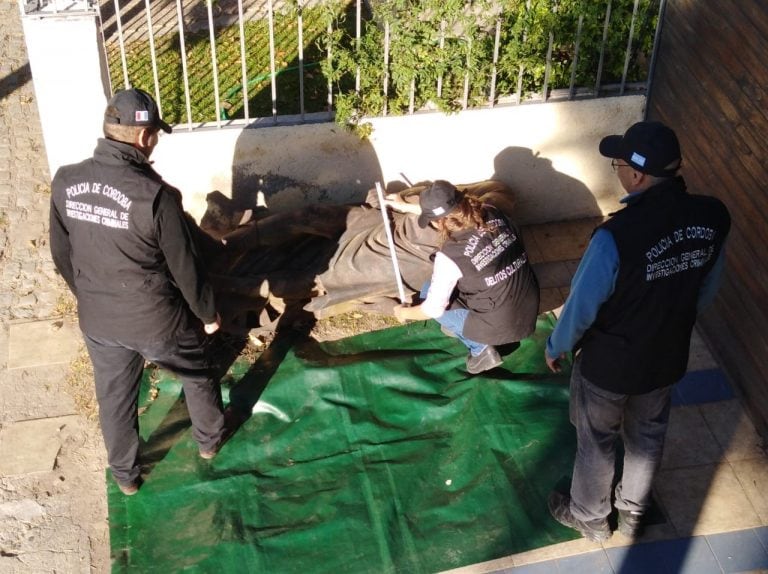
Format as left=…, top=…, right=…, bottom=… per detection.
left=154, top=96, right=645, bottom=223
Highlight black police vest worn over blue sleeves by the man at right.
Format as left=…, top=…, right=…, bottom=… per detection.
left=580, top=177, right=730, bottom=395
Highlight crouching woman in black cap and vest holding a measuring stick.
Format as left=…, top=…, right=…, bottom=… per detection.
left=387, top=180, right=539, bottom=374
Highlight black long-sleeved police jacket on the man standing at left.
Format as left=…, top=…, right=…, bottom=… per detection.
left=50, top=139, right=216, bottom=342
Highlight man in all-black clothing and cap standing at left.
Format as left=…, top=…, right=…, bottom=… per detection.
left=50, top=89, right=224, bottom=495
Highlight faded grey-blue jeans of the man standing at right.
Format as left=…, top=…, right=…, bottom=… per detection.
left=570, top=357, right=672, bottom=521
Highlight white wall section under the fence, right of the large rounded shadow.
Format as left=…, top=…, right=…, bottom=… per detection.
left=372, top=96, right=645, bottom=223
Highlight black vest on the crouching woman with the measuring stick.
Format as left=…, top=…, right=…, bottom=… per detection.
left=440, top=205, right=539, bottom=345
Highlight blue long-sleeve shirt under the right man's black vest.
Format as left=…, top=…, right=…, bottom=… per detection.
left=546, top=200, right=725, bottom=359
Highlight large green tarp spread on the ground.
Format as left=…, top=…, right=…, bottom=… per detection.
left=108, top=315, right=575, bottom=574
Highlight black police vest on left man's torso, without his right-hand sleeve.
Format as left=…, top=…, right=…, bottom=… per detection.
left=51, top=139, right=186, bottom=342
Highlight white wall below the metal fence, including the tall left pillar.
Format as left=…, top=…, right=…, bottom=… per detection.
left=23, top=9, right=645, bottom=223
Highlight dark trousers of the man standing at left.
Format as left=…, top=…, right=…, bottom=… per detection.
left=84, top=317, right=224, bottom=484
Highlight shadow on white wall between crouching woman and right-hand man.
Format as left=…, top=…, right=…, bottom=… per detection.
left=491, top=147, right=602, bottom=225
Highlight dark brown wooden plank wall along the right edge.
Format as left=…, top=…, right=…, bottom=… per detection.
left=648, top=0, right=768, bottom=436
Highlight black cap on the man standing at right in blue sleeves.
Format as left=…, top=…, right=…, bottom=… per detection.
left=600, top=122, right=681, bottom=177
